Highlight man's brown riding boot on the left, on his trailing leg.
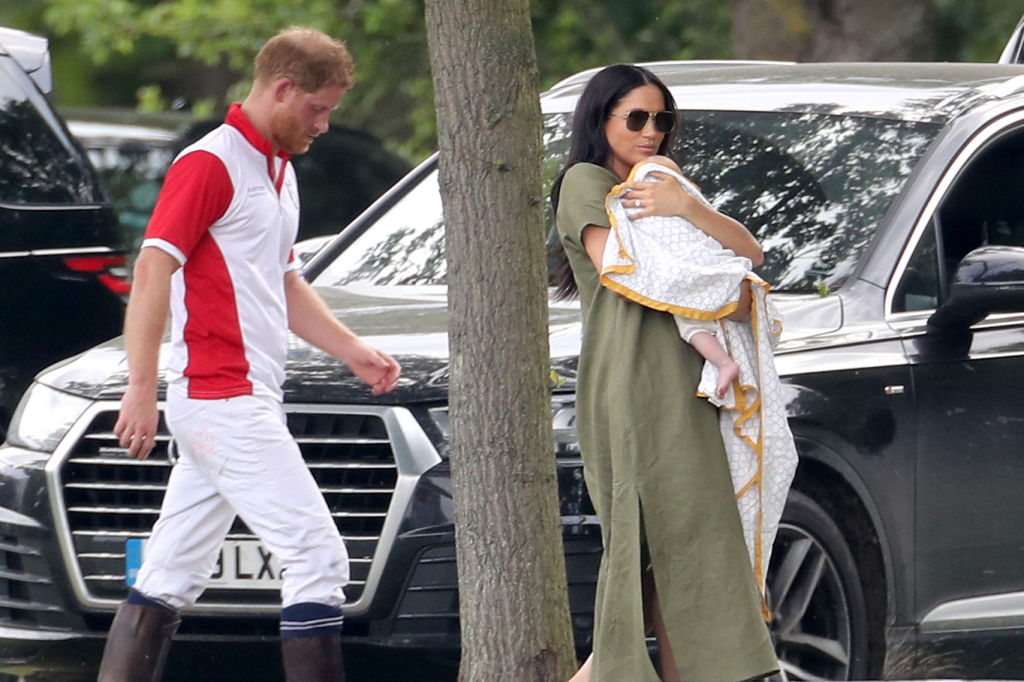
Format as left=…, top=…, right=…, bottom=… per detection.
left=97, top=603, right=181, bottom=682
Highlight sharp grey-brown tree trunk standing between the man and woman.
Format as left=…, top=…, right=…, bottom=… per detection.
left=426, top=0, right=574, bottom=682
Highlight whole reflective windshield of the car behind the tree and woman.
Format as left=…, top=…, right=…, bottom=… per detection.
left=316, top=112, right=938, bottom=292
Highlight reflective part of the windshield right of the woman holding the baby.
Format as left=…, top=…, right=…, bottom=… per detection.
left=675, top=112, right=938, bottom=292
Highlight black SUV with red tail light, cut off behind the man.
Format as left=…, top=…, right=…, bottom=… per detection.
left=0, top=28, right=128, bottom=434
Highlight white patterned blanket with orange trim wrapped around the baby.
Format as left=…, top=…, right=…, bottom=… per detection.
left=601, top=163, right=797, bottom=615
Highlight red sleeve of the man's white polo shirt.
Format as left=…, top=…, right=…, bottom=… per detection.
left=145, top=151, right=234, bottom=258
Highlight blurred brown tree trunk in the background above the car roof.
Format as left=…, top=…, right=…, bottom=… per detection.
left=730, top=0, right=935, bottom=61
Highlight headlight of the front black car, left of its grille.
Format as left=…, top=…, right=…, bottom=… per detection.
left=7, top=384, right=92, bottom=453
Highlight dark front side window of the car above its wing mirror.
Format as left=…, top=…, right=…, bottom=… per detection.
left=893, top=128, right=1024, bottom=312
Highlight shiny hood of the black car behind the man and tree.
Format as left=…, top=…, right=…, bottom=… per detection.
left=37, top=280, right=581, bottom=404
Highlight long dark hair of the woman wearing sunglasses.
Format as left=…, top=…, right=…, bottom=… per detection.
left=549, top=63, right=676, bottom=299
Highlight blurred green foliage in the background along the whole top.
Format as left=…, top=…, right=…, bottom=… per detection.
left=0, top=0, right=1024, bottom=159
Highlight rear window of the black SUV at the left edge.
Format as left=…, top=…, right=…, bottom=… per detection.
left=0, top=59, right=100, bottom=204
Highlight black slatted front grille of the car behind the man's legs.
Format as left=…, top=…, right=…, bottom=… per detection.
left=60, top=407, right=398, bottom=607
